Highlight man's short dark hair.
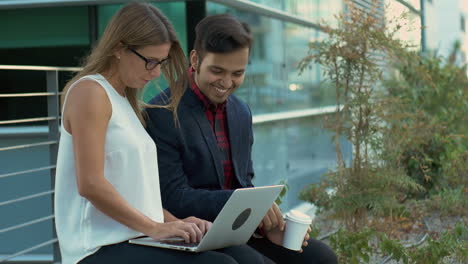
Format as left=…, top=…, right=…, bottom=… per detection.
left=194, top=14, right=252, bottom=63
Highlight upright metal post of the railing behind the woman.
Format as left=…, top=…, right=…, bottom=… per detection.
left=46, top=70, right=61, bottom=263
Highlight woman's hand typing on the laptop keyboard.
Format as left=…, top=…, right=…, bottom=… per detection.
left=144, top=221, right=203, bottom=243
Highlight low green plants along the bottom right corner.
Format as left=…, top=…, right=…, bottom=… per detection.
left=330, top=223, right=468, bottom=264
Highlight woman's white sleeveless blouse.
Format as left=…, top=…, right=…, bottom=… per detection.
left=54, top=74, right=164, bottom=264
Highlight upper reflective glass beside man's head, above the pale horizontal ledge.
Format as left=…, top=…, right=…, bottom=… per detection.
left=207, top=1, right=334, bottom=114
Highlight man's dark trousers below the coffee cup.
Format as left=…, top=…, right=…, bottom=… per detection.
left=248, top=238, right=338, bottom=264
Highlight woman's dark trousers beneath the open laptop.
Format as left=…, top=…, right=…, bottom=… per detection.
left=79, top=242, right=272, bottom=264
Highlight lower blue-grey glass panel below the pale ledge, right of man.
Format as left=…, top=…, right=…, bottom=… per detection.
left=253, top=116, right=351, bottom=211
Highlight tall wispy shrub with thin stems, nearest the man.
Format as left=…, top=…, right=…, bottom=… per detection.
left=301, top=1, right=421, bottom=230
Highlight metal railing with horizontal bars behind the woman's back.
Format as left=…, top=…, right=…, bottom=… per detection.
left=0, top=65, right=80, bottom=263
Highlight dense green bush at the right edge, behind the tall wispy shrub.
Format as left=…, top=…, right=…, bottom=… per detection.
left=384, top=44, right=468, bottom=192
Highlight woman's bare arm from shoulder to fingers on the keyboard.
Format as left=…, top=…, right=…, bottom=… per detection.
left=64, top=81, right=201, bottom=241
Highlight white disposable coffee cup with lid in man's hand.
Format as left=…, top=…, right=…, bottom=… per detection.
left=283, top=210, right=312, bottom=251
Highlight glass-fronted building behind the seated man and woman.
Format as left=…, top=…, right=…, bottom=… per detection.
left=0, top=0, right=467, bottom=263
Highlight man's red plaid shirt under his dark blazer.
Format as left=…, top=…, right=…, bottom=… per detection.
left=189, top=67, right=235, bottom=189
